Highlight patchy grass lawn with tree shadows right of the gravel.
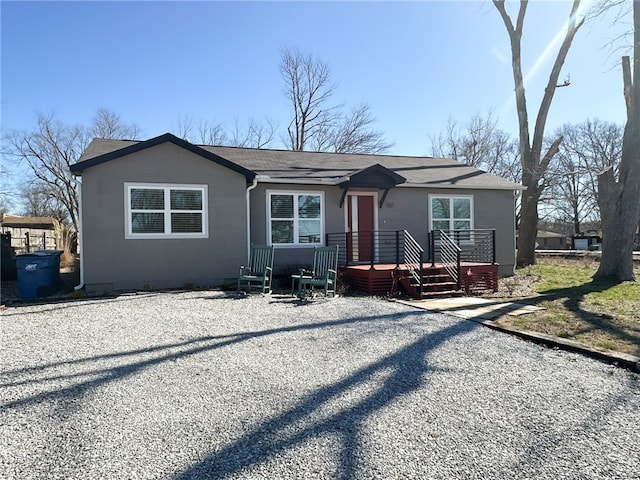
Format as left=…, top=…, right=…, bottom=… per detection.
left=497, top=258, right=640, bottom=356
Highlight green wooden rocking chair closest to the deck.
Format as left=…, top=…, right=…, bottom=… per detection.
left=296, top=245, right=338, bottom=298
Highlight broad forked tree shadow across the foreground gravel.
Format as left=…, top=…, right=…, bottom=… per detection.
left=175, top=313, right=476, bottom=480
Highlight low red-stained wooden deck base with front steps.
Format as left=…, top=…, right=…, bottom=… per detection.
left=338, top=262, right=498, bottom=296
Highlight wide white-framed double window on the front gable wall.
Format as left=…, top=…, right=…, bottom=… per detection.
left=125, top=183, right=209, bottom=238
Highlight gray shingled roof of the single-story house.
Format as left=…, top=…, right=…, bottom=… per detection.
left=72, top=135, right=523, bottom=190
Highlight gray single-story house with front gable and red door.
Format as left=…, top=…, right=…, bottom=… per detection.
left=71, top=134, right=522, bottom=292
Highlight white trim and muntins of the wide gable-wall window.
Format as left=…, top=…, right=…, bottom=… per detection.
left=124, top=182, right=209, bottom=240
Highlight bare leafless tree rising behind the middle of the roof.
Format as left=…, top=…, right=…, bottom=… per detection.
left=280, top=49, right=392, bottom=153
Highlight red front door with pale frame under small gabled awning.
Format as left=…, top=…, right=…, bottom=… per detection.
left=347, top=195, right=375, bottom=262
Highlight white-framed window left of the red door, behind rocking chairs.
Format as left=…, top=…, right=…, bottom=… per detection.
left=267, top=191, right=324, bottom=245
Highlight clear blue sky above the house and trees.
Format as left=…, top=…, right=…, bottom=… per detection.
left=1, top=0, right=630, bottom=161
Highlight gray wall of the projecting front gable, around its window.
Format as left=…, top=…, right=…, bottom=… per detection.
left=82, top=143, right=247, bottom=292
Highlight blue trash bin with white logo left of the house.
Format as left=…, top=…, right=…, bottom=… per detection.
left=16, top=253, right=60, bottom=298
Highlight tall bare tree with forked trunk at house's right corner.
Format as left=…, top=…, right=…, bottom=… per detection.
left=493, top=0, right=584, bottom=267
